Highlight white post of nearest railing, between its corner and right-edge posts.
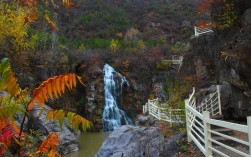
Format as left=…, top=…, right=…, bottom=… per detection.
left=203, top=111, right=213, bottom=157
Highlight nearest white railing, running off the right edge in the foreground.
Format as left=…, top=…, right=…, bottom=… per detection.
left=185, top=87, right=251, bottom=157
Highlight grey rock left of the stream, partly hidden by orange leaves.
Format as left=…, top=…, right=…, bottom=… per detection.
left=28, top=105, right=79, bottom=154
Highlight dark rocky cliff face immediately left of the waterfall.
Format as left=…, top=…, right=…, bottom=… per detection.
left=77, top=62, right=104, bottom=131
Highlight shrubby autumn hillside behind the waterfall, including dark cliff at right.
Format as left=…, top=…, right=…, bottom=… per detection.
left=0, top=0, right=251, bottom=130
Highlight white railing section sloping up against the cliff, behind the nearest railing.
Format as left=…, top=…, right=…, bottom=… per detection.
left=196, top=85, right=222, bottom=116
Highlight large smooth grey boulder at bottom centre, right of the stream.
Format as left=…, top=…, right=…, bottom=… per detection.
left=96, top=125, right=183, bottom=157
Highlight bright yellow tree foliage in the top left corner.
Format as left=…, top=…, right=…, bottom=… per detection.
left=0, top=3, right=32, bottom=52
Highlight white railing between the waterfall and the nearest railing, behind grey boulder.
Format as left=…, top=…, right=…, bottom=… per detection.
left=143, top=98, right=185, bottom=125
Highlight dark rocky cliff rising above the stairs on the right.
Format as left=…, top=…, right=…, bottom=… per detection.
left=182, top=6, right=251, bottom=119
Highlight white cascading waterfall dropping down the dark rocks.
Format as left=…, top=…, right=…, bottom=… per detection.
left=102, top=64, right=132, bottom=131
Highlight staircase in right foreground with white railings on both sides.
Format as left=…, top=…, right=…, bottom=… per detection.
left=185, top=86, right=251, bottom=157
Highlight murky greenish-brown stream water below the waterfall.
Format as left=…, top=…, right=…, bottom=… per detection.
left=64, top=132, right=110, bottom=157
